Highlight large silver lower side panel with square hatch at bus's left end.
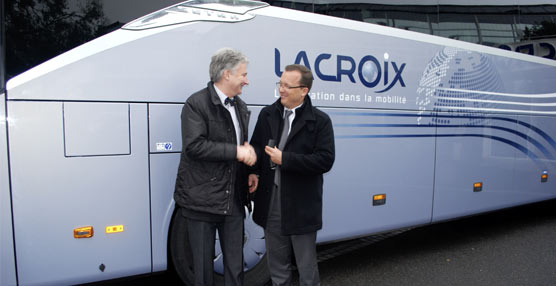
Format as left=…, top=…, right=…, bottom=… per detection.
left=8, top=101, right=151, bottom=285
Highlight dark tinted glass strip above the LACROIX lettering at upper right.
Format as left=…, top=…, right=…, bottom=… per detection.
left=266, top=0, right=556, bottom=59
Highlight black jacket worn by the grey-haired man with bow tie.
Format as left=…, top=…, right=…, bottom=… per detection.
left=174, top=82, right=250, bottom=215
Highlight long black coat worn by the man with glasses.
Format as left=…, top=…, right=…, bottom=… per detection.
left=251, top=96, right=335, bottom=235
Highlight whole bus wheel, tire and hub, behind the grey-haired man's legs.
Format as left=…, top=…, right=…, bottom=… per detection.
left=169, top=207, right=270, bottom=286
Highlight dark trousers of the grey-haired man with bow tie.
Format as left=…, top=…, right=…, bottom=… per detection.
left=187, top=212, right=243, bottom=286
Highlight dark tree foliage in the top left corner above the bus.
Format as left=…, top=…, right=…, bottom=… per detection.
left=4, top=0, right=105, bottom=79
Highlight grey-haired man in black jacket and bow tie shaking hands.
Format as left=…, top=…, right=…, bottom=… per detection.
left=174, top=48, right=257, bottom=285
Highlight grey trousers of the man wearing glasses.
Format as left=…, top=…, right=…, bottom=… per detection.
left=264, top=229, right=320, bottom=286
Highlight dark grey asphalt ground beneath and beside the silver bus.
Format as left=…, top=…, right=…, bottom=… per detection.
left=107, top=200, right=556, bottom=286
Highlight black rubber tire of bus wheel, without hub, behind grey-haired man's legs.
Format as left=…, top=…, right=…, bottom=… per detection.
left=169, top=209, right=270, bottom=286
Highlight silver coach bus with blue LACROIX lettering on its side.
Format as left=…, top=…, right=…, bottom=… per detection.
left=0, top=0, right=556, bottom=285
